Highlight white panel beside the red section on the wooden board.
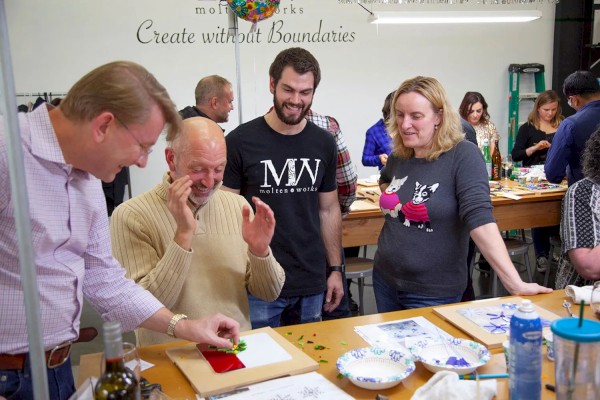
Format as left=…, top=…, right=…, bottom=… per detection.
left=237, top=332, right=292, bottom=368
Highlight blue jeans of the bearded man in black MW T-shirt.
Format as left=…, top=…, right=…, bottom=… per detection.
left=248, top=293, right=323, bottom=329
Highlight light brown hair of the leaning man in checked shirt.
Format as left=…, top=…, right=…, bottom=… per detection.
left=59, top=61, right=181, bottom=140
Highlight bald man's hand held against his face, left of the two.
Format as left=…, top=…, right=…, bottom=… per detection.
left=167, top=175, right=196, bottom=251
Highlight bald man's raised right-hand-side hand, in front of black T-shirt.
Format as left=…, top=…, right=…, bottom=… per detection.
left=242, top=197, right=275, bottom=257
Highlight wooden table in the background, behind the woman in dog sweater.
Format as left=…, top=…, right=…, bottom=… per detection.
left=342, top=181, right=566, bottom=247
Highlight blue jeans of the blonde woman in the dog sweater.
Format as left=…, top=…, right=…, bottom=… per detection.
left=373, top=269, right=462, bottom=313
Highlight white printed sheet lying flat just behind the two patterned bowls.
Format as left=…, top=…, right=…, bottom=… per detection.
left=354, top=317, right=451, bottom=349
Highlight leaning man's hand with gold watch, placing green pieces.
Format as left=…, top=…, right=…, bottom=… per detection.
left=175, top=314, right=240, bottom=349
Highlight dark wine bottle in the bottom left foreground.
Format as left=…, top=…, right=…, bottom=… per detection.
left=94, top=321, right=141, bottom=400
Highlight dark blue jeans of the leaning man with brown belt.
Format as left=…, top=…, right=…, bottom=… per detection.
left=0, top=356, right=75, bottom=400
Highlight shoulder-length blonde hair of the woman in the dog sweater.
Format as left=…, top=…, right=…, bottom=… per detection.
left=386, top=76, right=465, bottom=161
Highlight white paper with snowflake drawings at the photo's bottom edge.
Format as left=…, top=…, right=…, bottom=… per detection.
left=206, top=372, right=354, bottom=400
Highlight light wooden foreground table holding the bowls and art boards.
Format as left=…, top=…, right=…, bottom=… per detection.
left=78, top=290, right=594, bottom=400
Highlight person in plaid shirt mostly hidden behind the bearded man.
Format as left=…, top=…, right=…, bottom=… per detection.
left=306, top=110, right=357, bottom=320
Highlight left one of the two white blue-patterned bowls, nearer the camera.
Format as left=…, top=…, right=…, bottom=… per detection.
left=336, top=347, right=415, bottom=390
